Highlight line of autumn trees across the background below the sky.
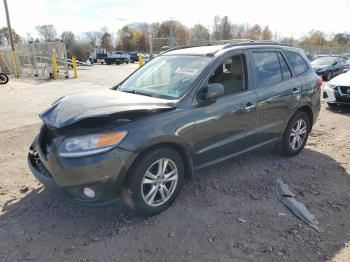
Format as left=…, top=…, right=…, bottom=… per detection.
left=0, top=16, right=350, bottom=60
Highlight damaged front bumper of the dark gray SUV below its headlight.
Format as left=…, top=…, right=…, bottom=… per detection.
left=28, top=135, right=136, bottom=206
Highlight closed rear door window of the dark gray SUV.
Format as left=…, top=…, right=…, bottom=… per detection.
left=253, top=52, right=283, bottom=87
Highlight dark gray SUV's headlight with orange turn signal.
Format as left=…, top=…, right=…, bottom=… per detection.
left=58, top=131, right=127, bottom=157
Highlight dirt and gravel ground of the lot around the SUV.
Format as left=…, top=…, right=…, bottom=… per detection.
left=0, top=65, right=350, bottom=261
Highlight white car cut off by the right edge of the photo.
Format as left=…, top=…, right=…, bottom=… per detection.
left=323, top=71, right=350, bottom=107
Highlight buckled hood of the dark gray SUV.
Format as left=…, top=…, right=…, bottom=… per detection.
left=39, top=90, right=174, bottom=128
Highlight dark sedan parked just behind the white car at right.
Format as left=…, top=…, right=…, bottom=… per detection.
left=311, top=56, right=349, bottom=81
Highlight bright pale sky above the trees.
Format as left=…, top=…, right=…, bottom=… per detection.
left=0, top=0, right=350, bottom=38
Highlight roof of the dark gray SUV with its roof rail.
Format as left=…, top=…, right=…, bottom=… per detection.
left=163, top=41, right=293, bottom=56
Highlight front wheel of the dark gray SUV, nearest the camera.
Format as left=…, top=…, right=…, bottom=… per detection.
left=122, top=147, right=184, bottom=216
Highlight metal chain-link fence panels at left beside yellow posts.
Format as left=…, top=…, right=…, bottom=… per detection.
left=0, top=42, right=69, bottom=79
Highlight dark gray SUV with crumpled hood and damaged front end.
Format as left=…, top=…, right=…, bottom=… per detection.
left=28, top=42, right=322, bottom=215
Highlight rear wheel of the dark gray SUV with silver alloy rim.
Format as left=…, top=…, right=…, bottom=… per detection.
left=278, top=111, right=311, bottom=156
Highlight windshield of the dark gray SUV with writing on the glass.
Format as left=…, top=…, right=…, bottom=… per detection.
left=119, top=55, right=212, bottom=99
